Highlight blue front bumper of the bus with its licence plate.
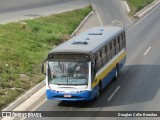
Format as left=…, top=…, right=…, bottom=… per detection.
left=46, top=89, right=94, bottom=101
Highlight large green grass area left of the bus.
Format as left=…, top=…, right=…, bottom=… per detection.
left=0, top=6, right=92, bottom=110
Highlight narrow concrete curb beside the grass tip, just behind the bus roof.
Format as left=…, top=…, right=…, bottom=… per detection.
left=70, top=10, right=94, bottom=37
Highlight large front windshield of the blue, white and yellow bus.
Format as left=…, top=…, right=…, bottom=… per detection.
left=48, top=61, right=89, bottom=85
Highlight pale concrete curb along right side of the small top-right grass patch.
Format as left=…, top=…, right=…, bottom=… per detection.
left=133, top=0, right=160, bottom=18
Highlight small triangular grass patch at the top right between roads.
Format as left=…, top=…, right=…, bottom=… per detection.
left=127, top=0, right=154, bottom=15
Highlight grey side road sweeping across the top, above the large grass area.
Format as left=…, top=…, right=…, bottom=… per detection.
left=0, top=0, right=132, bottom=26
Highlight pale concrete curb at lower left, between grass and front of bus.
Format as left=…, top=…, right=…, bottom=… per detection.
left=2, top=80, right=45, bottom=111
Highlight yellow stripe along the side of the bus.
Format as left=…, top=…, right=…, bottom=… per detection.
left=92, top=51, right=126, bottom=88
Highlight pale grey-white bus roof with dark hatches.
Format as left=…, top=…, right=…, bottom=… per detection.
left=50, top=26, right=124, bottom=54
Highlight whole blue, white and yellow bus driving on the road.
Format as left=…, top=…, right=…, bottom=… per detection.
left=42, top=26, right=126, bottom=101
